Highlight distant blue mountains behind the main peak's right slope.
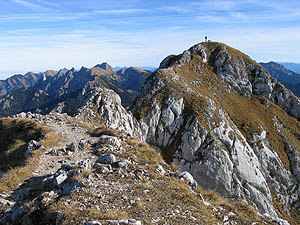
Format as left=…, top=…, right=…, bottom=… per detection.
left=260, top=62, right=300, bottom=97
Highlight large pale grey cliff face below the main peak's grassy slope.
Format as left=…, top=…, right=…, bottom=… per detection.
left=134, top=92, right=277, bottom=217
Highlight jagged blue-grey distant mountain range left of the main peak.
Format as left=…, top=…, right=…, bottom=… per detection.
left=0, top=63, right=151, bottom=116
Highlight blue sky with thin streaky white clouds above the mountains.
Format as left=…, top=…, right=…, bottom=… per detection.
left=0, top=0, right=300, bottom=79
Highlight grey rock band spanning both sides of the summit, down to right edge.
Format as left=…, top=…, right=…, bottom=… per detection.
left=160, top=43, right=300, bottom=119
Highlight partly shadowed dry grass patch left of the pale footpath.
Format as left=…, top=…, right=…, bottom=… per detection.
left=0, top=118, right=60, bottom=192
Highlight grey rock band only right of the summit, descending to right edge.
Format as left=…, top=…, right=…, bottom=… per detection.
left=210, top=46, right=300, bottom=119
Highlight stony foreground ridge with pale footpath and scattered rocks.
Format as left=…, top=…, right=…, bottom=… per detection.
left=0, top=113, right=280, bottom=225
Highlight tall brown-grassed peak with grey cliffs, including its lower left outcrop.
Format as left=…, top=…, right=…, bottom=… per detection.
left=0, top=42, right=300, bottom=225
